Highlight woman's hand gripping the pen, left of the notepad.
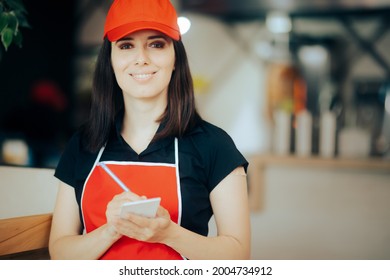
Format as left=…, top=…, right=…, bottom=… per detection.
left=106, top=192, right=145, bottom=239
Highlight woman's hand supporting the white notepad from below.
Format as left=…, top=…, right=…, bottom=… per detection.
left=116, top=206, right=172, bottom=243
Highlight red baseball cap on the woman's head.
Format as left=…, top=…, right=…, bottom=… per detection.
left=103, top=0, right=180, bottom=42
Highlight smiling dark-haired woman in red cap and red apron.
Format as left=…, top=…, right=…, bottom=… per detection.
left=49, top=0, right=250, bottom=259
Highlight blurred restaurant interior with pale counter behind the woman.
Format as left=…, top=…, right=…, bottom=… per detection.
left=0, top=0, right=390, bottom=259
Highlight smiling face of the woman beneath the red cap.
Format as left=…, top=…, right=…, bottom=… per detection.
left=111, top=30, right=175, bottom=103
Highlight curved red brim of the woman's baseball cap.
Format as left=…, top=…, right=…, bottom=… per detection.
left=105, top=21, right=180, bottom=42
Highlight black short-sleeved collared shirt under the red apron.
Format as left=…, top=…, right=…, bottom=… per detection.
left=54, top=118, right=248, bottom=236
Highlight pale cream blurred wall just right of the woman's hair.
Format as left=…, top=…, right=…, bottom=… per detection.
left=183, top=14, right=269, bottom=154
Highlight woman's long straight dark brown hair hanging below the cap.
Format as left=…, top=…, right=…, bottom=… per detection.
left=82, top=39, right=200, bottom=152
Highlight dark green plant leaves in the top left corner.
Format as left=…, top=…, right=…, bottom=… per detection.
left=0, top=0, right=30, bottom=52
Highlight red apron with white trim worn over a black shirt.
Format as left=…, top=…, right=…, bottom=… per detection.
left=81, top=139, right=183, bottom=260
